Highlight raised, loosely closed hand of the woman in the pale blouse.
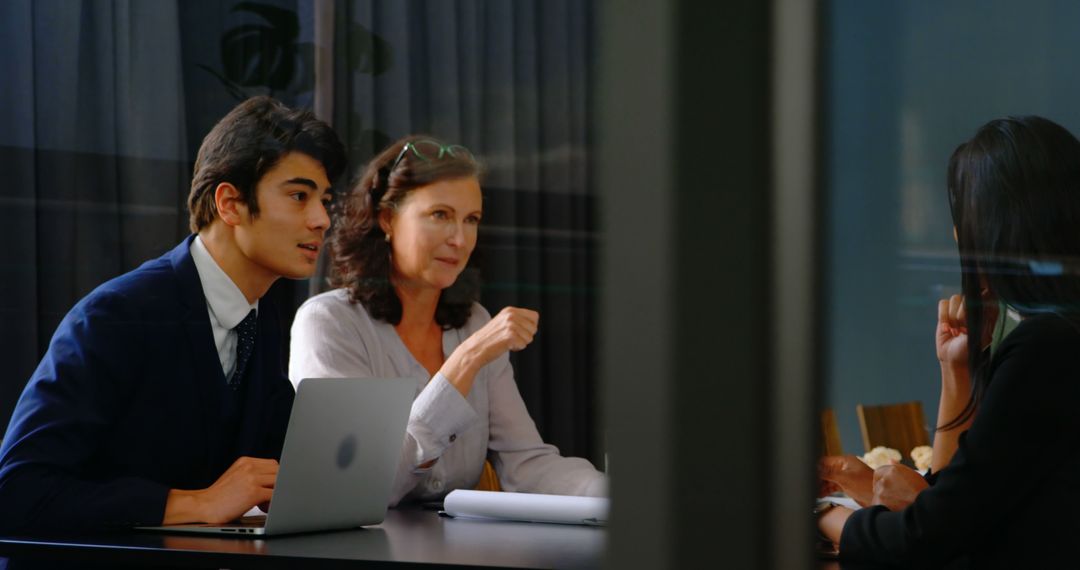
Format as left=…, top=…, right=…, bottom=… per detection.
left=440, top=307, right=540, bottom=396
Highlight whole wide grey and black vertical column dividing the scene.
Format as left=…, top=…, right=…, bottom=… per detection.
left=596, top=0, right=816, bottom=568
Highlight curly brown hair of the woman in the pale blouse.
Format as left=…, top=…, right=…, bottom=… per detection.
left=327, top=135, right=483, bottom=330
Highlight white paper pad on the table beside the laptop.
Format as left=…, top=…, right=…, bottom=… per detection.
left=443, top=489, right=608, bottom=525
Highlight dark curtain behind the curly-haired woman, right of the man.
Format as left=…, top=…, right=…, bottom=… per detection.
left=324, top=0, right=603, bottom=465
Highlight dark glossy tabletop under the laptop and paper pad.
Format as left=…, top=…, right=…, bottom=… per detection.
left=0, top=508, right=607, bottom=569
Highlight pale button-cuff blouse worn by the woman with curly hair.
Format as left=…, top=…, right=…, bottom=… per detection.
left=288, top=289, right=607, bottom=506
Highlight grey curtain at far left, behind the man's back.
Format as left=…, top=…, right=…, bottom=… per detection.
left=0, top=0, right=190, bottom=425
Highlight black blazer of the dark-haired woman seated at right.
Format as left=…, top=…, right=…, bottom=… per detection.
left=840, top=314, right=1080, bottom=568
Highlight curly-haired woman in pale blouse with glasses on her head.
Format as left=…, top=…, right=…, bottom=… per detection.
left=288, top=136, right=607, bottom=505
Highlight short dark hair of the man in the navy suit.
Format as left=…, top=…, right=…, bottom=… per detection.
left=188, top=96, right=347, bottom=232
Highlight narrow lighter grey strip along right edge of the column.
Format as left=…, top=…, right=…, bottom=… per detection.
left=769, top=0, right=824, bottom=570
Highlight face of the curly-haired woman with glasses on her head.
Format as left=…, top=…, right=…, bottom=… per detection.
left=379, top=177, right=482, bottom=290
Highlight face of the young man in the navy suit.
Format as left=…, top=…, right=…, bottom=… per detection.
left=235, top=152, right=330, bottom=279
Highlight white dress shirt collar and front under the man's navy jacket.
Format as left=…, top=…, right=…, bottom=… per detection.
left=191, top=235, right=259, bottom=381
